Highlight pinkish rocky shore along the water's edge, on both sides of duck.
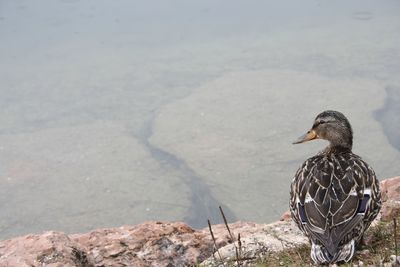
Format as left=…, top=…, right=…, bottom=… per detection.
left=0, top=177, right=400, bottom=267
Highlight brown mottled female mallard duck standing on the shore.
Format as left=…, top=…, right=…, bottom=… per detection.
left=290, top=111, right=381, bottom=264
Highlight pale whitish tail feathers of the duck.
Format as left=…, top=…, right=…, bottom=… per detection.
left=311, top=239, right=355, bottom=264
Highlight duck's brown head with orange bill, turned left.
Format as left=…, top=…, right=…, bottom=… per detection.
left=293, top=110, right=353, bottom=150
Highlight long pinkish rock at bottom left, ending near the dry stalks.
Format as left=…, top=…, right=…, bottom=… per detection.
left=0, top=222, right=212, bottom=267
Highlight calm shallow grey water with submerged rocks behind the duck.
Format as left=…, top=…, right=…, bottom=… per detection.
left=0, top=0, right=400, bottom=239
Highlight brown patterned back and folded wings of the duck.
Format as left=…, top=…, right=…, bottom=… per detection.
left=290, top=153, right=380, bottom=256
